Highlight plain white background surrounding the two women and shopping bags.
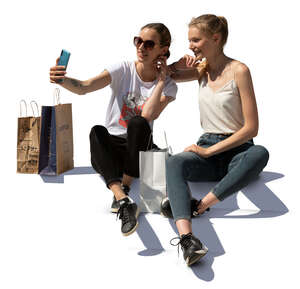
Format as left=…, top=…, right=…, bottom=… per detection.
left=0, top=0, right=300, bottom=289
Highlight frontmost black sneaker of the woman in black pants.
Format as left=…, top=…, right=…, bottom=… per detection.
left=117, top=198, right=139, bottom=236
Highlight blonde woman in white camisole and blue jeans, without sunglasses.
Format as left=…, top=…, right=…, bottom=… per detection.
left=162, top=14, right=269, bottom=265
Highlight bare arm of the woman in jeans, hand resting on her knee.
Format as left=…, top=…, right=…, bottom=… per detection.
left=185, top=63, right=258, bottom=157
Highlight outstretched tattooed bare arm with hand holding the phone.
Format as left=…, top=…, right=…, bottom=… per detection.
left=50, top=58, right=111, bottom=95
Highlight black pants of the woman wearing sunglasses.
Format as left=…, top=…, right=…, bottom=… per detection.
left=90, top=116, right=157, bottom=187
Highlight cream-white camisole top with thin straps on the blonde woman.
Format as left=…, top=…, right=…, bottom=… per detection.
left=199, top=77, right=244, bottom=134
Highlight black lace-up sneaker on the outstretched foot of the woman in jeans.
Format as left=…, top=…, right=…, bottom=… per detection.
left=170, top=233, right=208, bottom=266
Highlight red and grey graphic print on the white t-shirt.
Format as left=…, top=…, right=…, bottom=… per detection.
left=119, top=92, right=147, bottom=128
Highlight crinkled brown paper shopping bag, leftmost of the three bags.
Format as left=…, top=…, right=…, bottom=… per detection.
left=17, top=100, right=40, bottom=174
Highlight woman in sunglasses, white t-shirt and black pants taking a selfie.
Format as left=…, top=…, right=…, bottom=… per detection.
left=50, top=23, right=177, bottom=236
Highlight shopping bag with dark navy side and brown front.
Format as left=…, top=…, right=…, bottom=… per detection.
left=39, top=88, right=74, bottom=175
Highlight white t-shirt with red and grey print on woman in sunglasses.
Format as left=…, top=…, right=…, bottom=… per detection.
left=105, top=61, right=177, bottom=135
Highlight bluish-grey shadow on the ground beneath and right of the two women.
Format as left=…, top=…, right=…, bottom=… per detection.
left=130, top=172, right=288, bottom=281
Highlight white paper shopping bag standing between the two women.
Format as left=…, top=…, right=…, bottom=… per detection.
left=139, top=130, right=171, bottom=213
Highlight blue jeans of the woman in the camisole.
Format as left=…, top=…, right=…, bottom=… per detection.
left=166, top=133, right=269, bottom=221
